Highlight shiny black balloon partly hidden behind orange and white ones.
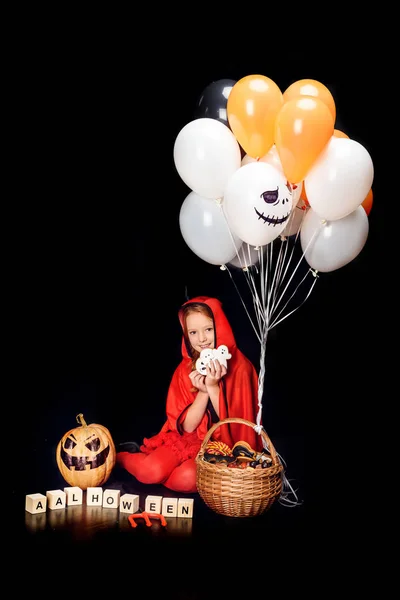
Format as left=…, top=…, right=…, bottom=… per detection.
left=194, top=79, right=236, bottom=127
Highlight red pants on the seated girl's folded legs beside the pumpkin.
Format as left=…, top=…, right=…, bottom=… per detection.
left=117, top=446, right=197, bottom=493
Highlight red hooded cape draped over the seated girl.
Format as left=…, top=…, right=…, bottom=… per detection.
left=142, top=296, right=262, bottom=460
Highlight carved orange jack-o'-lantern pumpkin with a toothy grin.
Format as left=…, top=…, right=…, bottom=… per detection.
left=56, top=414, right=116, bottom=490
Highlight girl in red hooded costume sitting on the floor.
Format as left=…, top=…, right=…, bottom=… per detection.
left=117, top=296, right=262, bottom=493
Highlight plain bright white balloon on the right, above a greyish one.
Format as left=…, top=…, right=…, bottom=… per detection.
left=304, top=136, right=374, bottom=221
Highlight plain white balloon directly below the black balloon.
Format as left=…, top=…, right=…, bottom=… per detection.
left=174, top=118, right=241, bottom=199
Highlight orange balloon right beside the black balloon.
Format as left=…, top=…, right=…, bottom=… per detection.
left=226, top=75, right=283, bottom=158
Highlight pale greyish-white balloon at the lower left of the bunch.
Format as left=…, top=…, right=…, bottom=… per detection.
left=179, top=191, right=242, bottom=265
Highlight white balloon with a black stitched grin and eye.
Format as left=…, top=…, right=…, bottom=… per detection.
left=222, top=161, right=292, bottom=246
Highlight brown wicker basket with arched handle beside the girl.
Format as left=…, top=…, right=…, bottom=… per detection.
left=196, top=417, right=283, bottom=517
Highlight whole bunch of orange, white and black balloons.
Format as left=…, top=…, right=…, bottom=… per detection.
left=173, top=74, right=374, bottom=272
